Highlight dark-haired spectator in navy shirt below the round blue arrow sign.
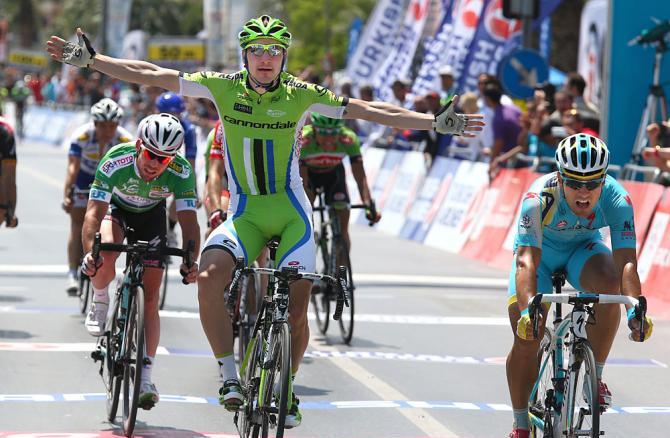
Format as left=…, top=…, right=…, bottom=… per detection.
left=484, top=82, right=521, bottom=168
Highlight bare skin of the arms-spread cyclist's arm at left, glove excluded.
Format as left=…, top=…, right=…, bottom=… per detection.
left=47, top=28, right=179, bottom=93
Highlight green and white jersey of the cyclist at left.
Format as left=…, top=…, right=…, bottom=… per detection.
left=89, top=143, right=196, bottom=213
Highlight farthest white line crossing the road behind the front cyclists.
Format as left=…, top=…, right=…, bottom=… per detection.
left=0, top=264, right=508, bottom=288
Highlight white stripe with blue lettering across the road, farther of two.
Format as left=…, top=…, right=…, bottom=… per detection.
left=0, top=342, right=668, bottom=368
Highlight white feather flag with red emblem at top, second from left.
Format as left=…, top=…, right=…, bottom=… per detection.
left=372, top=0, right=430, bottom=104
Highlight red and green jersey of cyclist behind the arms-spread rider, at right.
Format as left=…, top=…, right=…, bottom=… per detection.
left=300, top=125, right=361, bottom=172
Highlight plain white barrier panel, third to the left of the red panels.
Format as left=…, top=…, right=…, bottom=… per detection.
left=379, top=151, right=426, bottom=235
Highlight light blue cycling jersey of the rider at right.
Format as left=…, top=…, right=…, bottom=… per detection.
left=514, top=172, right=635, bottom=250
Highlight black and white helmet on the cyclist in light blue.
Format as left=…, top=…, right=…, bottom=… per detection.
left=556, top=134, right=610, bottom=180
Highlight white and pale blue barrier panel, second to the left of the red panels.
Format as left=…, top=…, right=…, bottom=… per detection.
left=400, top=157, right=460, bottom=242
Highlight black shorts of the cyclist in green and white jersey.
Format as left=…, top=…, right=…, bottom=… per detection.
left=105, top=201, right=167, bottom=268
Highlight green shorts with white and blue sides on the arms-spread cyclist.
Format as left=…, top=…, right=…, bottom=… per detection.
left=202, top=190, right=316, bottom=272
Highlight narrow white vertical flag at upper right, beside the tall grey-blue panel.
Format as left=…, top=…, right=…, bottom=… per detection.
left=577, top=0, right=609, bottom=105
